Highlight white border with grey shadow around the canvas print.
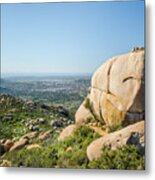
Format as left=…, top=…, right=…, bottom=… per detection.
left=0, top=0, right=155, bottom=180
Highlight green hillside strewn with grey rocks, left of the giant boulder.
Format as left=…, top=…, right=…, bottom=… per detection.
left=0, top=94, right=72, bottom=155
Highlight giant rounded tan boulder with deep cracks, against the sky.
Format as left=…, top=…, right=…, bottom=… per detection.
left=75, top=49, right=144, bottom=126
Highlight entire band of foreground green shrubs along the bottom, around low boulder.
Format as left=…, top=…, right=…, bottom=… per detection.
left=4, top=127, right=145, bottom=170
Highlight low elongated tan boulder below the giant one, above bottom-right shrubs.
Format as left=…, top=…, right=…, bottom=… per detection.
left=87, top=121, right=144, bottom=161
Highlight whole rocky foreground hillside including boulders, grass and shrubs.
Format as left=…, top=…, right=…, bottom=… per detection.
left=0, top=48, right=145, bottom=170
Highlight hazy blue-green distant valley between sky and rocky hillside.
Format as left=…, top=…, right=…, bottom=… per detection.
left=1, top=76, right=90, bottom=119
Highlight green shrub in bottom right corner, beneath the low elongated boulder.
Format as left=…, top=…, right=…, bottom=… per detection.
left=89, top=145, right=145, bottom=170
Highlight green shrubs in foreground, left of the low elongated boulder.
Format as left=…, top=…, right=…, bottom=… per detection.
left=5, top=127, right=99, bottom=168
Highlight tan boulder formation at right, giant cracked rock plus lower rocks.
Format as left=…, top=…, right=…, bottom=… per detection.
left=59, top=48, right=145, bottom=160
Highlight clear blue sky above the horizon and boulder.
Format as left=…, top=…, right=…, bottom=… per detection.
left=1, top=1, right=144, bottom=74
